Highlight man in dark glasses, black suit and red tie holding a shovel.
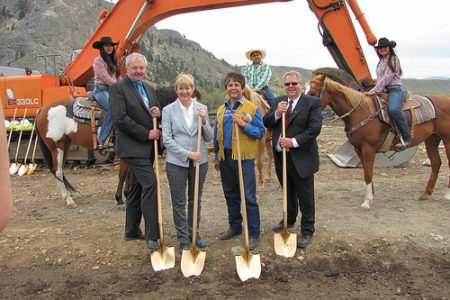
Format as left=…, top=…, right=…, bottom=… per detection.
left=263, top=71, right=322, bottom=248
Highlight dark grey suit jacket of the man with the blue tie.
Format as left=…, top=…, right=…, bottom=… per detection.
left=109, top=76, right=160, bottom=158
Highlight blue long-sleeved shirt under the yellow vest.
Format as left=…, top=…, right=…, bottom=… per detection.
left=214, top=96, right=266, bottom=160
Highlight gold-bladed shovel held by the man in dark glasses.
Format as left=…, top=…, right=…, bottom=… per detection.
left=273, top=112, right=297, bottom=257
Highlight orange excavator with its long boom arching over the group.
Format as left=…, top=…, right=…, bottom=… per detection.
left=0, top=0, right=377, bottom=163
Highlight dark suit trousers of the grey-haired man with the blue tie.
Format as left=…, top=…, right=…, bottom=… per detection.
left=122, top=157, right=159, bottom=240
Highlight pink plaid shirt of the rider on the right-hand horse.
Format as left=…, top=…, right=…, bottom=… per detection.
left=367, top=56, right=402, bottom=95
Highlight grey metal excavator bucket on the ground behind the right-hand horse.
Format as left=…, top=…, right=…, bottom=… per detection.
left=328, top=141, right=417, bottom=168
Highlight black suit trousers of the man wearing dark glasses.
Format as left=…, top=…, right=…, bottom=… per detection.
left=275, top=152, right=315, bottom=234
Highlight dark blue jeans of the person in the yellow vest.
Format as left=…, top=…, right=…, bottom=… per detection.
left=220, top=154, right=260, bottom=238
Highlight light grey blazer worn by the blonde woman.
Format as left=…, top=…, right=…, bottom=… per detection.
left=162, top=100, right=213, bottom=167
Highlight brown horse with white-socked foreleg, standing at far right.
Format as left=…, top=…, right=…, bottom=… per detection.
left=307, top=74, right=450, bottom=209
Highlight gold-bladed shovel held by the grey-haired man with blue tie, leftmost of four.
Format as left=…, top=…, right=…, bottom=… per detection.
left=150, top=117, right=175, bottom=272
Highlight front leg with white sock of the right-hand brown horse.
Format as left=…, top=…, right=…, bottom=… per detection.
left=355, top=145, right=375, bottom=210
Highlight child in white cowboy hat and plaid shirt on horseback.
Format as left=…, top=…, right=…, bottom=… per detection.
left=244, top=49, right=275, bottom=103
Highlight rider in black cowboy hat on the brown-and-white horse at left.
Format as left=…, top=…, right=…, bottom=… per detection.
left=92, top=36, right=121, bottom=150
